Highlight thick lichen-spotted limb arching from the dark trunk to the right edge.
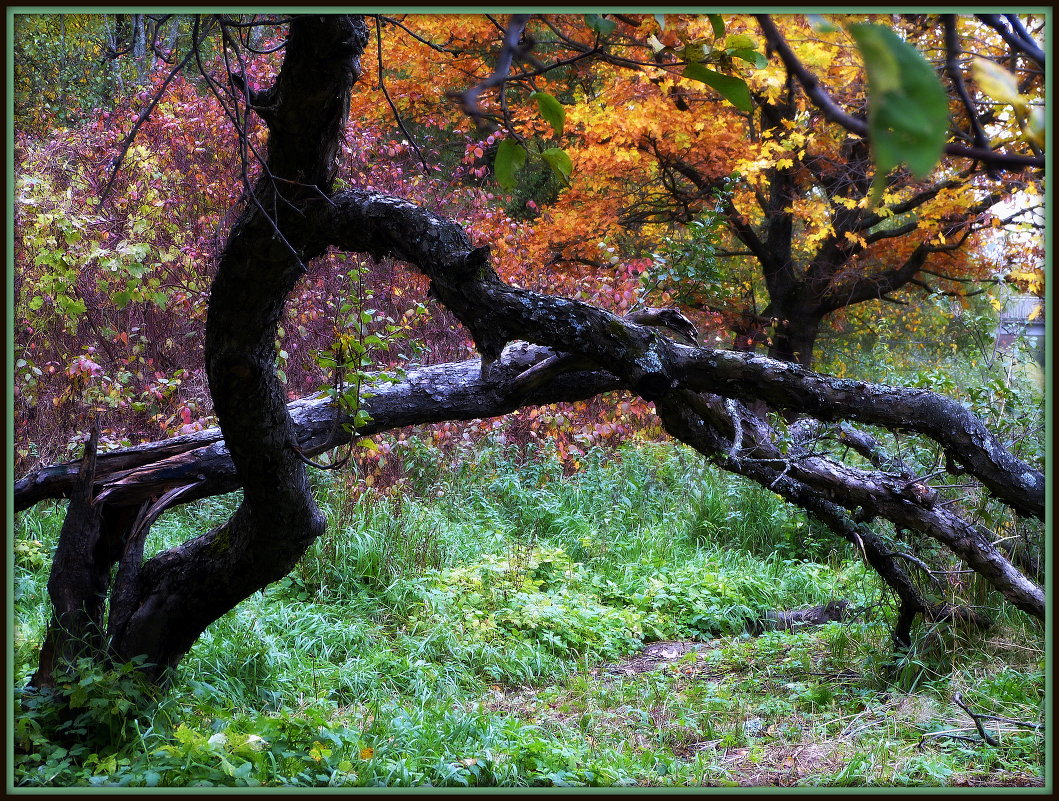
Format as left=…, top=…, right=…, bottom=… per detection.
left=304, top=191, right=1044, bottom=518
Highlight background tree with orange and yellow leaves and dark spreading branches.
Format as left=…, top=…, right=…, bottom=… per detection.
left=374, top=15, right=1043, bottom=364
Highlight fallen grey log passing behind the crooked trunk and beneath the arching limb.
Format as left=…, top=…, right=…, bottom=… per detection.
left=15, top=332, right=1044, bottom=627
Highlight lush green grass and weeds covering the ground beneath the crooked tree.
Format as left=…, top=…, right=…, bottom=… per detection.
left=14, top=442, right=1044, bottom=786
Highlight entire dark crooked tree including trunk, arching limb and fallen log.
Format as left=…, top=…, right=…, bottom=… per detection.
left=22, top=15, right=1044, bottom=683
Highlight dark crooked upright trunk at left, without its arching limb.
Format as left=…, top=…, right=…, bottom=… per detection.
left=28, top=15, right=367, bottom=680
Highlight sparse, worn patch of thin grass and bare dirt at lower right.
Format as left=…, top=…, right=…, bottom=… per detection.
left=486, top=626, right=1043, bottom=787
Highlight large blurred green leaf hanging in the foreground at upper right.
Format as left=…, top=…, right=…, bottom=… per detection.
left=849, top=22, right=949, bottom=203
